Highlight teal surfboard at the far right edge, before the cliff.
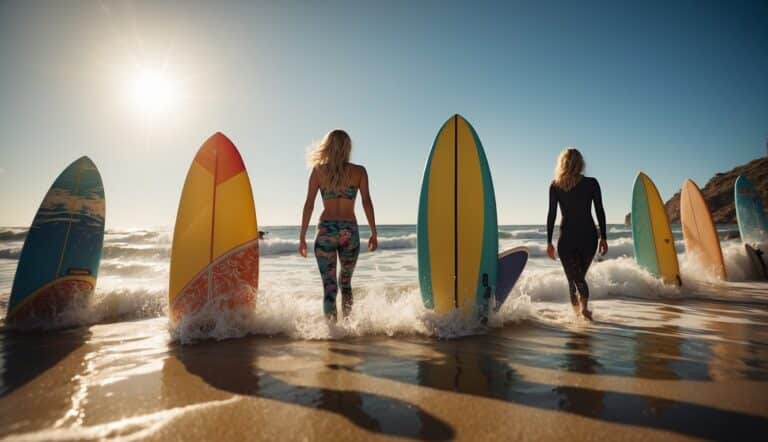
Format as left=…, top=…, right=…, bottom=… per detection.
left=733, top=175, right=768, bottom=247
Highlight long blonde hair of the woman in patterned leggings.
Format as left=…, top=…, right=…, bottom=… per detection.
left=307, top=129, right=352, bottom=192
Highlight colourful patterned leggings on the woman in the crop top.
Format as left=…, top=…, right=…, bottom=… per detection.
left=315, top=220, right=360, bottom=320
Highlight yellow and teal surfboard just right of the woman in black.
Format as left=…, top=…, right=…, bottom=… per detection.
left=631, top=172, right=682, bottom=285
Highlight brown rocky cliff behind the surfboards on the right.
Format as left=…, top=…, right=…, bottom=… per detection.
left=624, top=157, right=768, bottom=225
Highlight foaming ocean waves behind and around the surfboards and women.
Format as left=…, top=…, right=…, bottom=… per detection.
left=0, top=225, right=753, bottom=342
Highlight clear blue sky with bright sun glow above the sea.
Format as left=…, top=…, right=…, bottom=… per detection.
left=0, top=0, right=768, bottom=228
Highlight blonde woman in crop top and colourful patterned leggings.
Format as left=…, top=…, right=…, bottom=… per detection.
left=299, top=129, right=378, bottom=321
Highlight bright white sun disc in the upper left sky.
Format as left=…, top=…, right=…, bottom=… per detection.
left=127, top=67, right=179, bottom=116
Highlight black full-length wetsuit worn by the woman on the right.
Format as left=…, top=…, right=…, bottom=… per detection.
left=547, top=177, right=605, bottom=305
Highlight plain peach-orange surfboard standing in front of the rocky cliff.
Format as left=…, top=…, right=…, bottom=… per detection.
left=680, top=180, right=726, bottom=280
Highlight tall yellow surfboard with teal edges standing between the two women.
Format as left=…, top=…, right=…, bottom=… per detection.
left=417, top=115, right=499, bottom=320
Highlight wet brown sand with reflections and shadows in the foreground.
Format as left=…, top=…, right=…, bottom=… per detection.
left=0, top=289, right=768, bottom=441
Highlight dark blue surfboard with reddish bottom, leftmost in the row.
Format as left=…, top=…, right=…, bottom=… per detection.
left=6, top=157, right=105, bottom=323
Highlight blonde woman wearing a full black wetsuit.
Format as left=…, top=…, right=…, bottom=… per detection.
left=547, top=147, right=608, bottom=321
